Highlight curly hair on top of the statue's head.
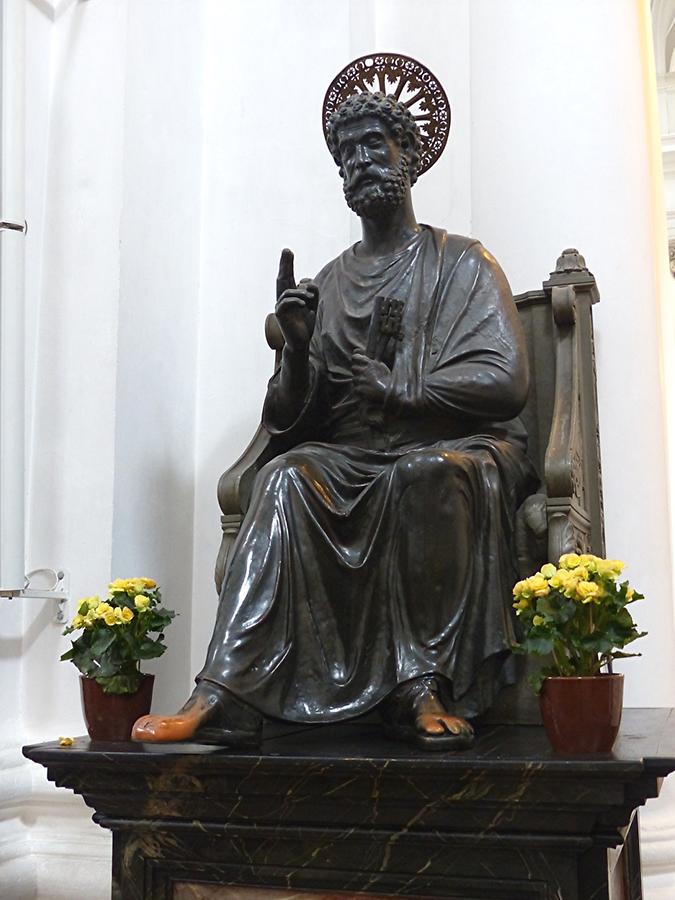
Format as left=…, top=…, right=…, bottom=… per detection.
left=327, top=91, right=420, bottom=185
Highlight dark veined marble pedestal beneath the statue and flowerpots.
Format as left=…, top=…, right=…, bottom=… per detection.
left=24, top=709, right=675, bottom=900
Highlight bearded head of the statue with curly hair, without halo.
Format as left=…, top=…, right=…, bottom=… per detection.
left=326, top=92, right=420, bottom=215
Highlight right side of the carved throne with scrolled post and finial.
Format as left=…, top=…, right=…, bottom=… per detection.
left=515, top=249, right=605, bottom=575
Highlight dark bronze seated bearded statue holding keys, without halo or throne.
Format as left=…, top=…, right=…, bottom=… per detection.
left=133, top=54, right=536, bottom=749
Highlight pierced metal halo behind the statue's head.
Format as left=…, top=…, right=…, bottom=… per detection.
left=322, top=53, right=450, bottom=175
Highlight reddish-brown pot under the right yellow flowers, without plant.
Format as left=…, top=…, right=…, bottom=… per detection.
left=539, top=675, right=623, bottom=754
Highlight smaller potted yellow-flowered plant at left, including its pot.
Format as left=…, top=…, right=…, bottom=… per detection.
left=61, top=578, right=175, bottom=741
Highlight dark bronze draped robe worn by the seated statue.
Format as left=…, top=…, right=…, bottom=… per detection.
left=198, top=226, right=534, bottom=722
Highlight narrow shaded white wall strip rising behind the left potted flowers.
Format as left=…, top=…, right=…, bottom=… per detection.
left=111, top=0, right=203, bottom=708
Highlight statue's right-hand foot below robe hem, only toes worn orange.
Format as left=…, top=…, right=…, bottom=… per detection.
left=381, top=675, right=474, bottom=750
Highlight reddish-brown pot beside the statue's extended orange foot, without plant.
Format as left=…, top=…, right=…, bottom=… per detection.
left=80, top=675, right=155, bottom=741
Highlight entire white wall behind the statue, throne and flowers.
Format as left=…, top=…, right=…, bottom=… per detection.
left=0, top=0, right=675, bottom=900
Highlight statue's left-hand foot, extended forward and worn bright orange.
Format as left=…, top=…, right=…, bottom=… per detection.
left=131, top=681, right=262, bottom=747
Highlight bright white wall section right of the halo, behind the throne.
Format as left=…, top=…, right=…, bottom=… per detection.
left=471, top=0, right=675, bottom=706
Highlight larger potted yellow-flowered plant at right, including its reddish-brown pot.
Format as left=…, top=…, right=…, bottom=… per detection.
left=513, top=553, right=646, bottom=753
